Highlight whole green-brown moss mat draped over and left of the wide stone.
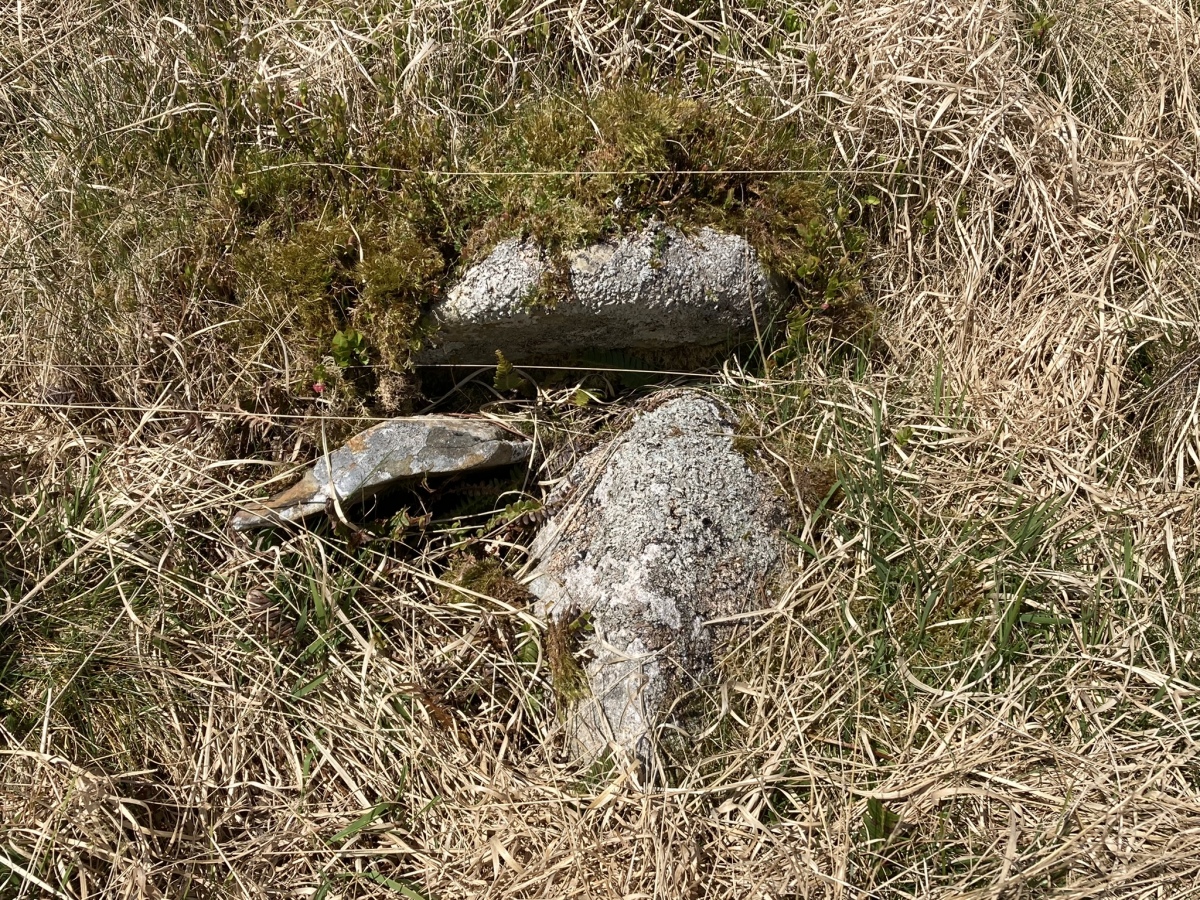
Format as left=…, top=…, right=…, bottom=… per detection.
left=58, top=70, right=863, bottom=420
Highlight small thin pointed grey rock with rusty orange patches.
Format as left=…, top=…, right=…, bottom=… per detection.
left=233, top=415, right=530, bottom=530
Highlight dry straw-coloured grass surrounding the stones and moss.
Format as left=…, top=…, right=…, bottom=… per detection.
left=0, top=0, right=1200, bottom=900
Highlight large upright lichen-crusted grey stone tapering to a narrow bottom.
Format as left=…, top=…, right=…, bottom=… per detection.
left=529, top=394, right=786, bottom=762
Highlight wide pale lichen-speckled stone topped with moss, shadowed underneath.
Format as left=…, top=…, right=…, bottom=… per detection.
left=416, top=224, right=773, bottom=365
